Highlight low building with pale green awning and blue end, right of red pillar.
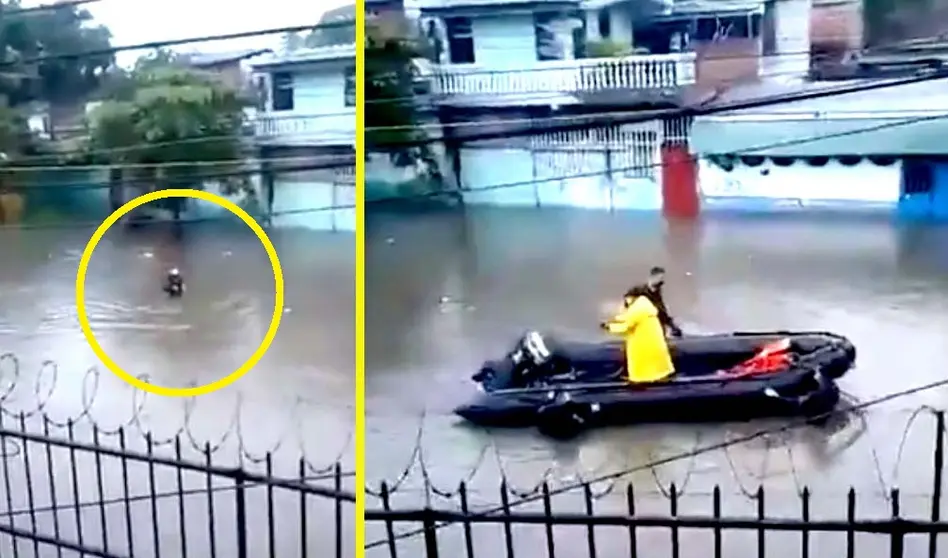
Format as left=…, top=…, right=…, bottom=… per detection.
left=691, top=80, right=948, bottom=221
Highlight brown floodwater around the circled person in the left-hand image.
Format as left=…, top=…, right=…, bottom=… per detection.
left=0, top=225, right=355, bottom=556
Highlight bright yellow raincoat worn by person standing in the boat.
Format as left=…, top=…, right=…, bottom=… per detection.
left=606, top=296, right=675, bottom=383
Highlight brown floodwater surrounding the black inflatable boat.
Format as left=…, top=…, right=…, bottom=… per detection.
left=366, top=208, right=948, bottom=557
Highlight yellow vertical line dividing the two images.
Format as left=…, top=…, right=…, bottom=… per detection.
left=353, top=0, right=365, bottom=558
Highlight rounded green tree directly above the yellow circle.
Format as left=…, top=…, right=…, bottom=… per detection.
left=89, top=53, right=252, bottom=219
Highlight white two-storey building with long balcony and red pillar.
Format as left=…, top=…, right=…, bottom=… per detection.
left=412, top=0, right=810, bottom=215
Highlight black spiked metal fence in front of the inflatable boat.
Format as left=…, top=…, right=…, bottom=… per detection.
left=365, top=412, right=948, bottom=558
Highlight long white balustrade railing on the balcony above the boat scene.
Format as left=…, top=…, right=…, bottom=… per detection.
left=433, top=53, right=695, bottom=96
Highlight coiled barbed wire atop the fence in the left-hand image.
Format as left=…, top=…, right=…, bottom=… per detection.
left=0, top=352, right=355, bottom=477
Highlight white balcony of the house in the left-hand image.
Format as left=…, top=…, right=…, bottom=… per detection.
left=254, top=107, right=355, bottom=146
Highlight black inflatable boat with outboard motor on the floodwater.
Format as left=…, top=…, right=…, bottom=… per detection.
left=455, top=331, right=856, bottom=437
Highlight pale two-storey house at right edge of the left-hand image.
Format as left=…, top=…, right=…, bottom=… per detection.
left=253, top=44, right=356, bottom=231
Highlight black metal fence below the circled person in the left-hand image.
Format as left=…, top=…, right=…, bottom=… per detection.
left=0, top=414, right=355, bottom=558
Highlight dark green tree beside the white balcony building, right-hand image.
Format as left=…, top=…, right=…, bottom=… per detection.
left=365, top=15, right=442, bottom=196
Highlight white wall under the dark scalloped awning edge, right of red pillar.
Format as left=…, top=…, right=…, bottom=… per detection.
left=698, top=159, right=902, bottom=209
